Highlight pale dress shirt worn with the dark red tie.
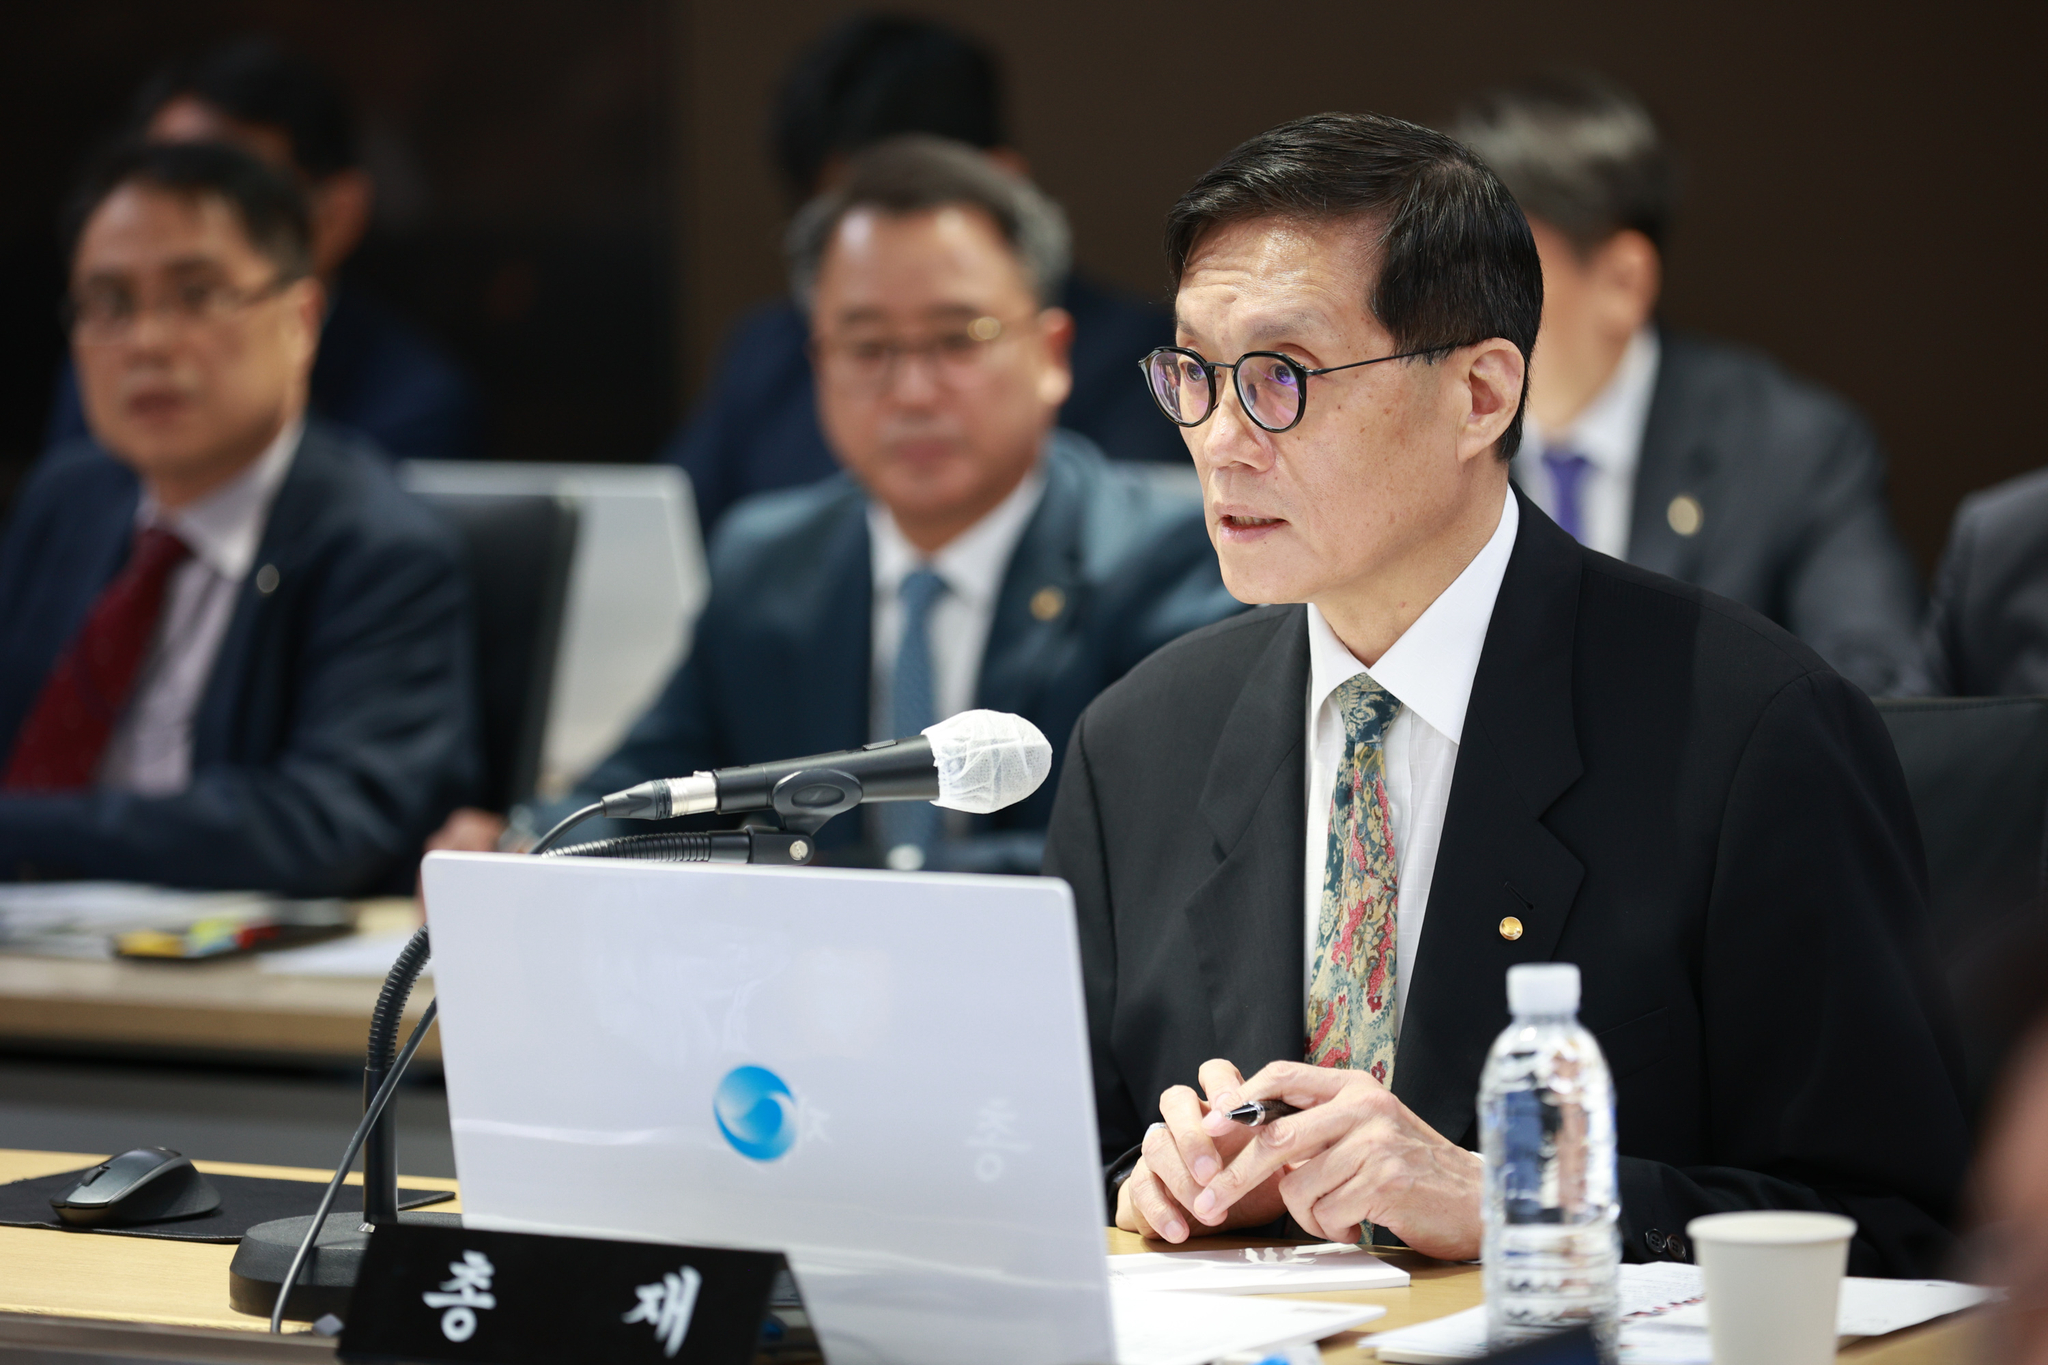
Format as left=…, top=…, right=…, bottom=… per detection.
left=98, top=417, right=305, bottom=796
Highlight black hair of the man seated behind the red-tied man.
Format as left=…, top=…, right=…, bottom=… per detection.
left=135, top=37, right=360, bottom=180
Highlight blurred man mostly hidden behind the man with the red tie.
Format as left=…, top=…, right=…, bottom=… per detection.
left=49, top=41, right=479, bottom=458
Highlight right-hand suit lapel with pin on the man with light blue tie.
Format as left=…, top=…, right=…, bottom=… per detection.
left=975, top=440, right=1087, bottom=720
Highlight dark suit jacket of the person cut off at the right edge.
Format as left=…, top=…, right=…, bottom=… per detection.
left=1927, top=469, right=2048, bottom=696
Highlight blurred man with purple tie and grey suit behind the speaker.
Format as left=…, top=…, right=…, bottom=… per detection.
left=1450, top=76, right=1929, bottom=696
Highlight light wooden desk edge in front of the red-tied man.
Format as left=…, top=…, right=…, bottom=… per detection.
left=0, top=898, right=440, bottom=1066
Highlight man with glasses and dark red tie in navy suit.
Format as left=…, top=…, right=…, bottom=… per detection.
left=0, top=143, right=475, bottom=896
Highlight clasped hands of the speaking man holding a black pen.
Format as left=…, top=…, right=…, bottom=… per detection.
left=1116, top=1060, right=1485, bottom=1261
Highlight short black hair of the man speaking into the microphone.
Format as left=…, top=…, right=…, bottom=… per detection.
left=1165, top=115, right=1542, bottom=460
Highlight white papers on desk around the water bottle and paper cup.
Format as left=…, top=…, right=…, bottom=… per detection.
left=1364, top=1263, right=1993, bottom=1365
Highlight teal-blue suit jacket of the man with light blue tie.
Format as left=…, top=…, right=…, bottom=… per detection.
left=578, top=432, right=1243, bottom=872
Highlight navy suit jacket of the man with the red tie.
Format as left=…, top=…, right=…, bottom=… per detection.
left=0, top=422, right=479, bottom=896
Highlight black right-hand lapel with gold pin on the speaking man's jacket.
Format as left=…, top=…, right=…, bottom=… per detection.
left=1395, top=493, right=1585, bottom=1142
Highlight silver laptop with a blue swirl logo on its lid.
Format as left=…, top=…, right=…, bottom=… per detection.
left=424, top=853, right=1128, bottom=1365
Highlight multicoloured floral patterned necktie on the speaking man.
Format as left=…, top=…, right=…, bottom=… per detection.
left=1309, top=673, right=1401, bottom=1085
